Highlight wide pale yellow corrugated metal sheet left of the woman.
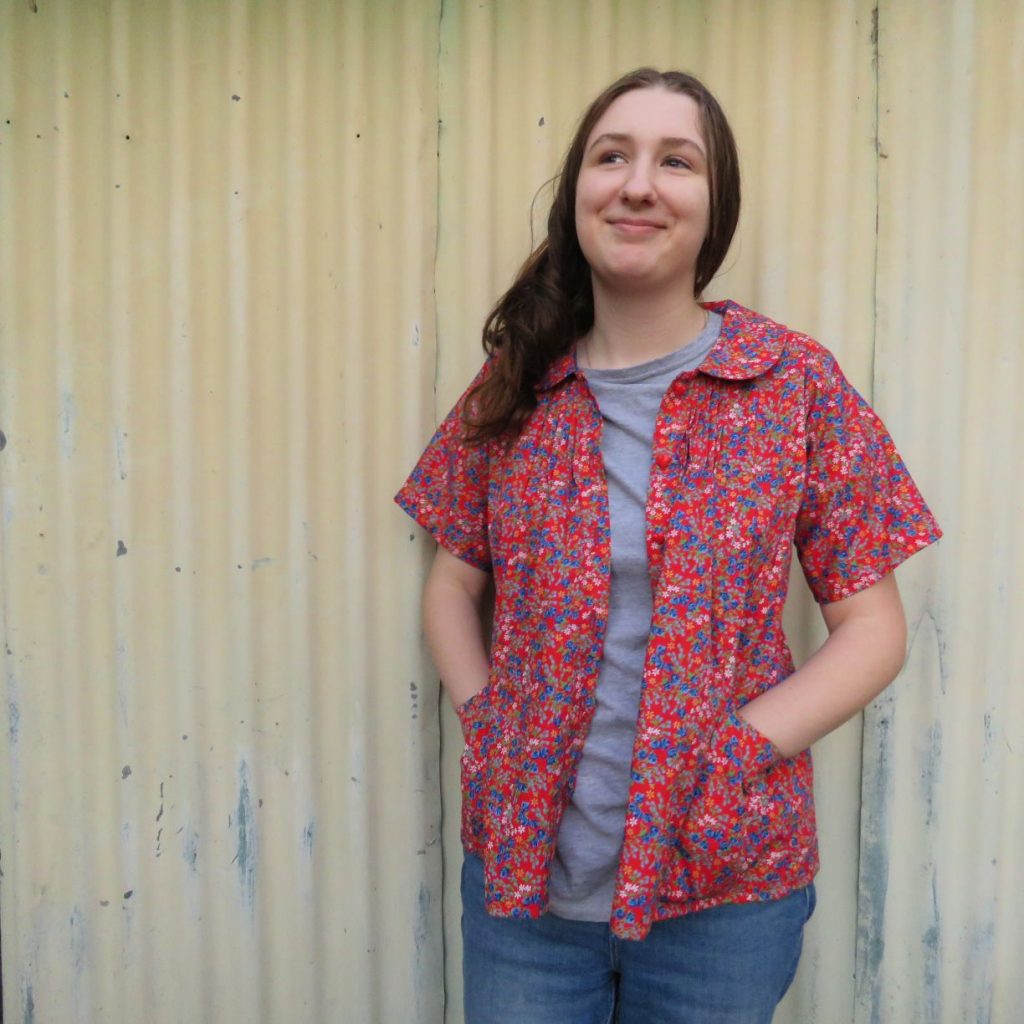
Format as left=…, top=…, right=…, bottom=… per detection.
left=0, top=0, right=443, bottom=1024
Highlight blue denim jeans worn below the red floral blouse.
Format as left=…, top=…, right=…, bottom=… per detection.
left=462, top=856, right=815, bottom=1024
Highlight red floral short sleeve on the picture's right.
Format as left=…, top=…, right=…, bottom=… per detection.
left=795, top=348, right=942, bottom=604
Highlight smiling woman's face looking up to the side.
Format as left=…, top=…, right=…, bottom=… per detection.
left=575, top=88, right=710, bottom=295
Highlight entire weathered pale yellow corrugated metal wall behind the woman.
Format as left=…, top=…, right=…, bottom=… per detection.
left=0, top=0, right=1024, bottom=1024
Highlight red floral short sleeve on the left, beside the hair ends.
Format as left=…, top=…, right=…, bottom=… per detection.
left=394, top=366, right=490, bottom=570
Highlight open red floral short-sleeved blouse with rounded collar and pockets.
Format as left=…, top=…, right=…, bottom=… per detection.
left=396, top=302, right=940, bottom=939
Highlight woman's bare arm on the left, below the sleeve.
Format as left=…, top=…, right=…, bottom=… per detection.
left=423, top=547, right=490, bottom=711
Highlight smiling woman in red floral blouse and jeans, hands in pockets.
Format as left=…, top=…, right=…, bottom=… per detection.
left=397, top=69, right=939, bottom=1024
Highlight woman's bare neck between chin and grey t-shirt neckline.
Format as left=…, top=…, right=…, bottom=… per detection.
left=581, top=281, right=708, bottom=370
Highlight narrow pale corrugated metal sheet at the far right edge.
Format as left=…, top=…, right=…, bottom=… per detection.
left=856, top=0, right=1024, bottom=1024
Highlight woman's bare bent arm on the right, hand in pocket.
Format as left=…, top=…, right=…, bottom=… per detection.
left=738, top=573, right=906, bottom=757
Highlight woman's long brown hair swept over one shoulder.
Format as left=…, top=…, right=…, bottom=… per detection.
left=463, top=68, right=739, bottom=443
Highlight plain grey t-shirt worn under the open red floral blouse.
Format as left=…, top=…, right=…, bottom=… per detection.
left=549, top=312, right=722, bottom=921
